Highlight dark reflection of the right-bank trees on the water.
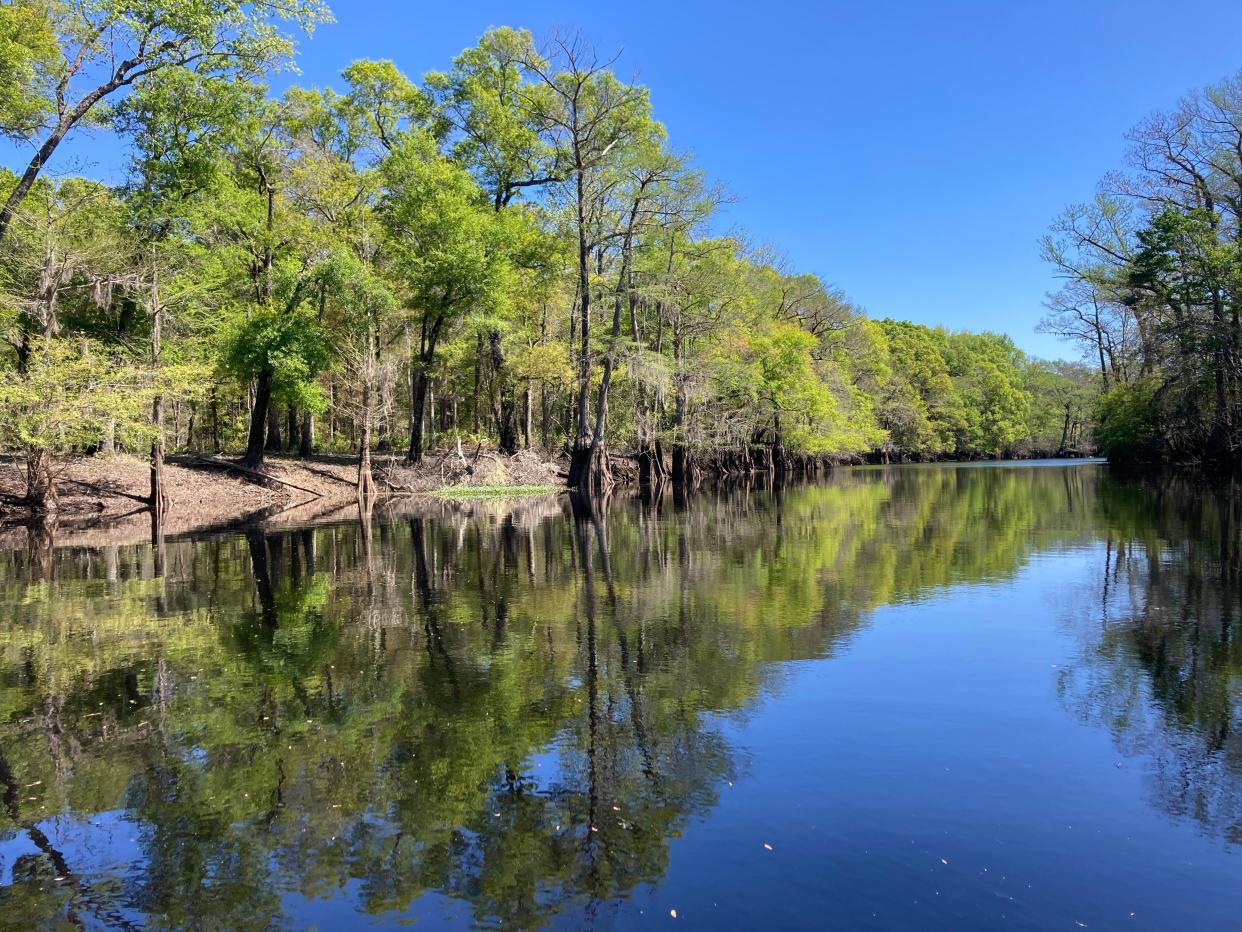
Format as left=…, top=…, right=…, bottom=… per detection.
left=1061, top=477, right=1242, bottom=844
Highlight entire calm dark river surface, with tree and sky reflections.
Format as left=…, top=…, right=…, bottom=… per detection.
left=0, top=465, right=1242, bottom=932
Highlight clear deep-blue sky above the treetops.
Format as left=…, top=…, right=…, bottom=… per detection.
left=9, top=0, right=1242, bottom=357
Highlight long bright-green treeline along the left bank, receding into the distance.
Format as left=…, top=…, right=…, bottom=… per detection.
left=0, top=0, right=1095, bottom=507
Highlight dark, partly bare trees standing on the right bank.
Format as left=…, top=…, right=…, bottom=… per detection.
left=1042, top=75, right=1242, bottom=472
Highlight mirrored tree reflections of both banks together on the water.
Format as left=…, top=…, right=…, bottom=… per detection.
left=0, top=467, right=1242, bottom=928
